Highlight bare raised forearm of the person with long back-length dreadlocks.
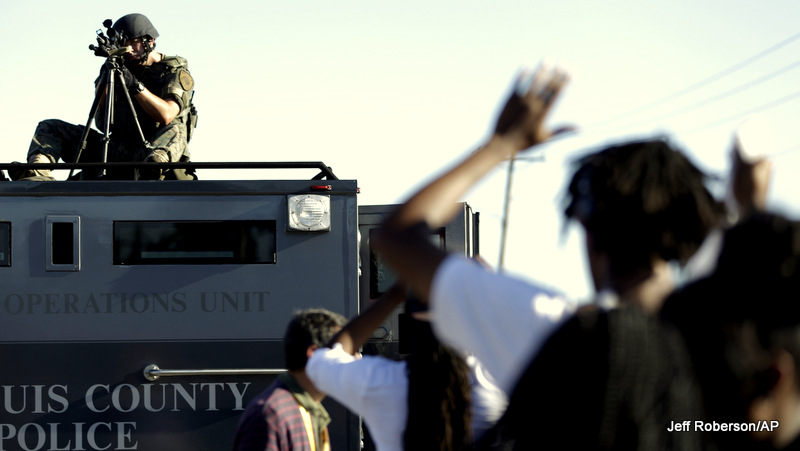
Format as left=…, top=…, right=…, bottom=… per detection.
left=328, top=284, right=405, bottom=354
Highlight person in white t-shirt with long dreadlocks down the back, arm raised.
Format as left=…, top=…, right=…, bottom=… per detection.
left=306, top=285, right=506, bottom=451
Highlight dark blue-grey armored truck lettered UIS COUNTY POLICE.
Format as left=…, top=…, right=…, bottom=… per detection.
left=0, top=163, right=477, bottom=451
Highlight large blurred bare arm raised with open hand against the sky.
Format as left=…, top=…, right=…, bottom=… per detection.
left=372, top=65, right=568, bottom=302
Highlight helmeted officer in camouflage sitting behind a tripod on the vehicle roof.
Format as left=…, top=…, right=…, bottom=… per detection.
left=14, top=14, right=196, bottom=180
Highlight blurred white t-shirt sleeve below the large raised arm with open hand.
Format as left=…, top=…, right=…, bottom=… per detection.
left=430, top=254, right=576, bottom=393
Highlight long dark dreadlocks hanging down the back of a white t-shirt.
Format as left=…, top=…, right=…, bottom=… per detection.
left=403, top=324, right=473, bottom=451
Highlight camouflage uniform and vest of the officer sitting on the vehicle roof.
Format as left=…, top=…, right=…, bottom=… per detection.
left=28, top=56, right=194, bottom=179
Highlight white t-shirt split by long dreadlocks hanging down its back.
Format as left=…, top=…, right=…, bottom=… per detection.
left=306, top=344, right=507, bottom=451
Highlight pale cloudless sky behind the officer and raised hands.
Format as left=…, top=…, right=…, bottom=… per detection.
left=0, top=0, right=800, bottom=299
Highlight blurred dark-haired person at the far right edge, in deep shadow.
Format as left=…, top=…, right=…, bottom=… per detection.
left=662, top=213, right=800, bottom=448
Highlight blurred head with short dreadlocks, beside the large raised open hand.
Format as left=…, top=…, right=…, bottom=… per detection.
left=564, top=139, right=723, bottom=289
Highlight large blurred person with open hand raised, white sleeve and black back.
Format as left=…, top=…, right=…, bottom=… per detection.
left=372, top=61, right=722, bottom=449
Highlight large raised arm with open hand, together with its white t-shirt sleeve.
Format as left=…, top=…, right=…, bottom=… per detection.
left=372, top=64, right=573, bottom=392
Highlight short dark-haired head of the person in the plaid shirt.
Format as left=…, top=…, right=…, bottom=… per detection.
left=283, top=309, right=347, bottom=371
